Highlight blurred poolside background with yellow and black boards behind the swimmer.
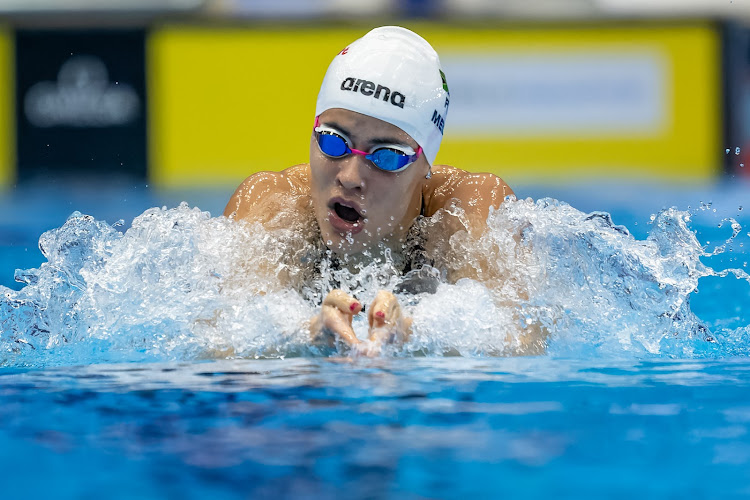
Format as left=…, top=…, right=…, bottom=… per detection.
left=0, top=0, right=750, bottom=286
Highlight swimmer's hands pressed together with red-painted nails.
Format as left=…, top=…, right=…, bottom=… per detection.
left=310, top=290, right=412, bottom=356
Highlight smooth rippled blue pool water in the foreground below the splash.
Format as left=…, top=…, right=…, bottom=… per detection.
left=0, top=357, right=750, bottom=499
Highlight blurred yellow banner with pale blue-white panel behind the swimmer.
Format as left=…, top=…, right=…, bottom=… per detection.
left=147, top=22, right=722, bottom=186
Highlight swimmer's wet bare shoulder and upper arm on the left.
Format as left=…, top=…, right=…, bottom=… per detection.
left=224, top=164, right=310, bottom=226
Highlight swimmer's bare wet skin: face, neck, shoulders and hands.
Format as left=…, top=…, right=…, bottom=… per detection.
left=224, top=109, right=513, bottom=355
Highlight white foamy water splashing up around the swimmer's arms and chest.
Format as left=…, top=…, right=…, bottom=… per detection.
left=0, top=199, right=750, bottom=366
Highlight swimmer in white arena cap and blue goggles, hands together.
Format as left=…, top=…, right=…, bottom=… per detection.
left=224, top=26, right=513, bottom=355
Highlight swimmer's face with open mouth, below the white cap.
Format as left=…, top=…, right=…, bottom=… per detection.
left=310, top=109, right=429, bottom=253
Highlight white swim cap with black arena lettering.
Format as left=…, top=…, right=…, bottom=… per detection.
left=315, top=26, right=449, bottom=165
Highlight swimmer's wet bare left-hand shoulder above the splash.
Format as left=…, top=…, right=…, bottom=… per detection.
left=224, top=163, right=310, bottom=219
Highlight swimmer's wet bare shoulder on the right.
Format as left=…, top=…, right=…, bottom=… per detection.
left=423, top=165, right=514, bottom=218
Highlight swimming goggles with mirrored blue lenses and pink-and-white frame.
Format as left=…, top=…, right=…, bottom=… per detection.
left=313, top=118, right=422, bottom=173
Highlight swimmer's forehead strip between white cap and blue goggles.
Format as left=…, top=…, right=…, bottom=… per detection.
left=319, top=108, right=418, bottom=149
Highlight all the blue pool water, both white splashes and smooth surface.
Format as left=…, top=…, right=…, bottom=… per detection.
left=0, top=178, right=750, bottom=498
